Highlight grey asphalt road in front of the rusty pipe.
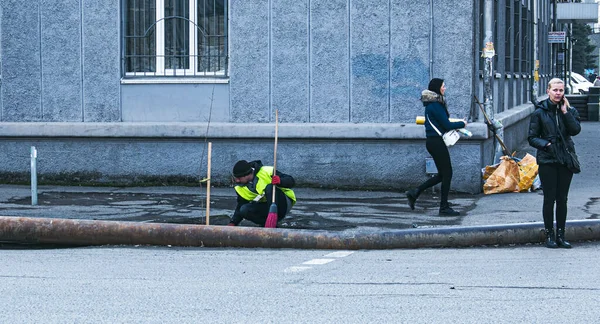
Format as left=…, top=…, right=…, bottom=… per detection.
left=0, top=243, right=600, bottom=323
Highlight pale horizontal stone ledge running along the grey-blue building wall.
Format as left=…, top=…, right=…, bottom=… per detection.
left=0, top=122, right=488, bottom=139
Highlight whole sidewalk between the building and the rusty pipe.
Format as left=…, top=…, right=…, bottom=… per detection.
left=0, top=122, right=600, bottom=235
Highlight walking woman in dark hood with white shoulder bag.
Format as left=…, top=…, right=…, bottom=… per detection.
left=406, top=78, right=467, bottom=216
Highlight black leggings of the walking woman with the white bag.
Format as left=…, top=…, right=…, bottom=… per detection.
left=418, top=136, right=452, bottom=207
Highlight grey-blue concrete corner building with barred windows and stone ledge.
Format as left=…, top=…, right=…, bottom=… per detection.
left=0, top=0, right=553, bottom=193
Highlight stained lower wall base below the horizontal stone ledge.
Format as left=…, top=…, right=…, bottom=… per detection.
left=0, top=139, right=481, bottom=193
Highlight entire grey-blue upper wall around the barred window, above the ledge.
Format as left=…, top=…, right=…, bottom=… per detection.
left=0, top=0, right=474, bottom=123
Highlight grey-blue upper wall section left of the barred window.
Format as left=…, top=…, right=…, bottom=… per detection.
left=0, top=0, right=121, bottom=122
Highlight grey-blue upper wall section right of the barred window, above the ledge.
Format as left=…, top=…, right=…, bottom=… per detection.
left=230, top=0, right=474, bottom=123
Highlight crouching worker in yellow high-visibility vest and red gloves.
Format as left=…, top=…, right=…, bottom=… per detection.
left=227, top=160, right=296, bottom=227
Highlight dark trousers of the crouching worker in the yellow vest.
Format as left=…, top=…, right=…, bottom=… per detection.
left=240, top=185, right=291, bottom=226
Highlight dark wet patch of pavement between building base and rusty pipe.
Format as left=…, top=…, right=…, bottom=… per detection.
left=0, top=186, right=475, bottom=231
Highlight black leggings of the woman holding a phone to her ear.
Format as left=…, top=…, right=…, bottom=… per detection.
left=538, top=164, right=573, bottom=229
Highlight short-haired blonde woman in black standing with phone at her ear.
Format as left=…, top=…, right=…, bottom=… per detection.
left=527, top=78, right=581, bottom=249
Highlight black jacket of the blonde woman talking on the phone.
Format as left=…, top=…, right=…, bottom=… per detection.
left=527, top=99, right=581, bottom=164
